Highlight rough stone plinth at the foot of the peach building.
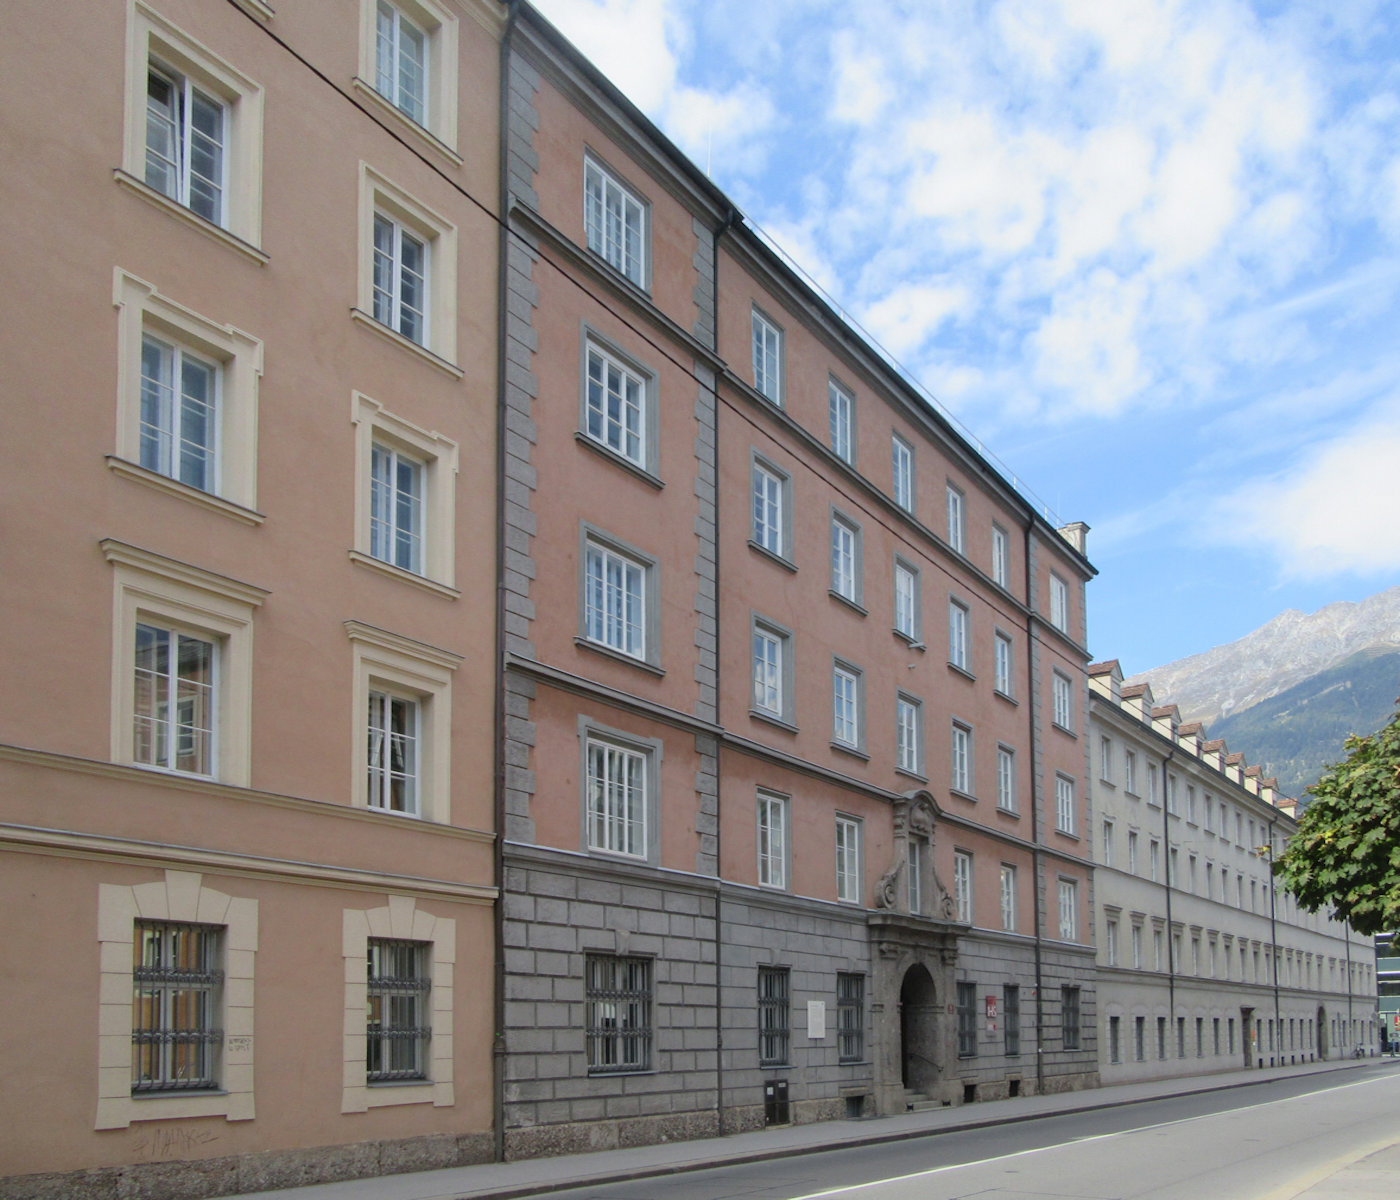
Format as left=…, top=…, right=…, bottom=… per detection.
left=0, top=1133, right=496, bottom=1200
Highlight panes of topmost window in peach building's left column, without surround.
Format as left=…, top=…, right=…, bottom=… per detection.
left=146, top=62, right=228, bottom=225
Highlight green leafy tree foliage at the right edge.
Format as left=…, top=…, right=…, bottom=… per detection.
left=1274, top=702, right=1400, bottom=934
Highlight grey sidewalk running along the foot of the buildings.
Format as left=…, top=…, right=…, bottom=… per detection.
left=225, top=1059, right=1394, bottom=1200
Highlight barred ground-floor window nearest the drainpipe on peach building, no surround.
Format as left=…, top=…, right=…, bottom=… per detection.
left=364, top=938, right=433, bottom=1084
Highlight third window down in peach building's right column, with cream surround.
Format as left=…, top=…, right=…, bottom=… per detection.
left=350, top=392, right=458, bottom=595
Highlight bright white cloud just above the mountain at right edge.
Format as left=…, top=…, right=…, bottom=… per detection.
left=1217, top=400, right=1400, bottom=578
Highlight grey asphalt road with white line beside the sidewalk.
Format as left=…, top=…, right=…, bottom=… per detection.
left=540, top=1068, right=1400, bottom=1200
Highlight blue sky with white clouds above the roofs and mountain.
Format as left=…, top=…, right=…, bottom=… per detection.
left=536, top=0, right=1400, bottom=674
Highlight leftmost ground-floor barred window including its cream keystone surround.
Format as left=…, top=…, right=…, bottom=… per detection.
left=94, top=871, right=259, bottom=1130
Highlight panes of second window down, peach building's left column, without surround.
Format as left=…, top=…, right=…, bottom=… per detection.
left=140, top=333, right=220, bottom=491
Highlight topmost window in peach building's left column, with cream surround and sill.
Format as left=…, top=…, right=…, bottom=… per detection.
left=116, top=0, right=265, bottom=247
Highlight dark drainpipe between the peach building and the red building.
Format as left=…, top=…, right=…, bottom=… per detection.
left=491, top=3, right=517, bottom=1162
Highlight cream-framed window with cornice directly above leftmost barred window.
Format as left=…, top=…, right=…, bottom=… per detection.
left=101, top=538, right=267, bottom=786
